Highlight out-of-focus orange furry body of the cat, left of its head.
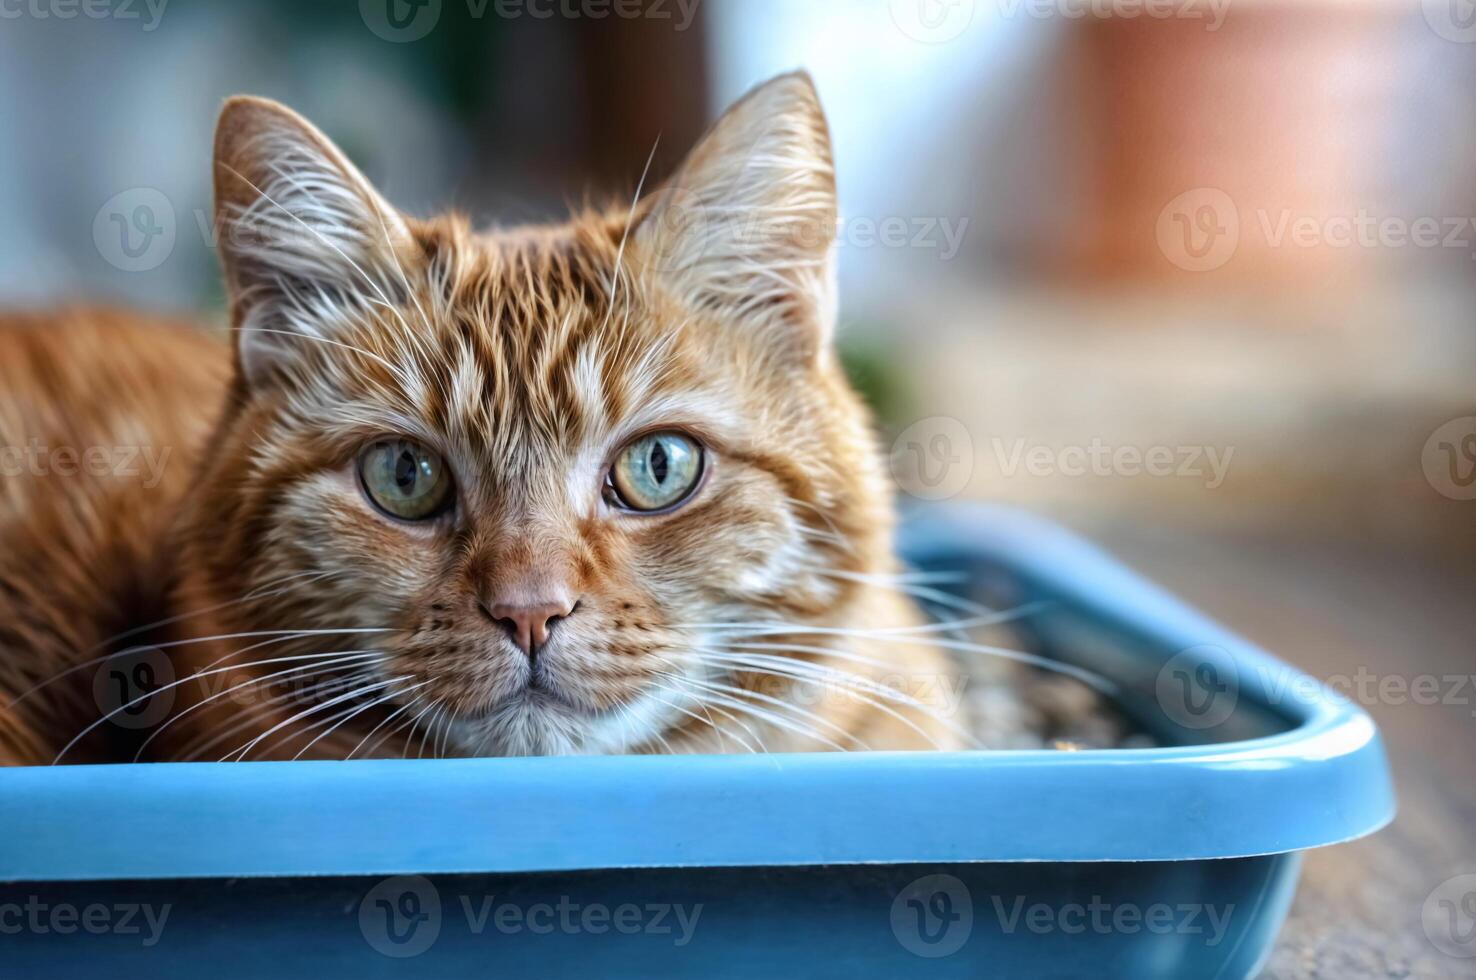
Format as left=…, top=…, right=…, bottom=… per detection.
left=0, top=308, right=230, bottom=765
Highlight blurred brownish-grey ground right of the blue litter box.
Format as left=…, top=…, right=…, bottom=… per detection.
left=1095, top=524, right=1476, bottom=980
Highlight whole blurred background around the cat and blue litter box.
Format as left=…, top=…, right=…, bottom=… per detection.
left=0, top=0, right=1476, bottom=977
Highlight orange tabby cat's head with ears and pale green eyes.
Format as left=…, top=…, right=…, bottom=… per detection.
left=192, top=74, right=889, bottom=754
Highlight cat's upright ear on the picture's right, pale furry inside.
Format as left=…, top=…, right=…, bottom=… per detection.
left=632, top=71, right=835, bottom=356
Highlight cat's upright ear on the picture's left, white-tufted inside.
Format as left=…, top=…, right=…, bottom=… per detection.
left=214, top=96, right=410, bottom=385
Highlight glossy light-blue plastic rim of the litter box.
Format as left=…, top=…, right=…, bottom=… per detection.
left=0, top=508, right=1395, bottom=881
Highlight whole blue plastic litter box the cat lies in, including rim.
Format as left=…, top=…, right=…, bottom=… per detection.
left=0, top=509, right=1395, bottom=980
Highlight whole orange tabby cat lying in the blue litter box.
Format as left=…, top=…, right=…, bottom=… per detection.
left=0, top=74, right=962, bottom=763
